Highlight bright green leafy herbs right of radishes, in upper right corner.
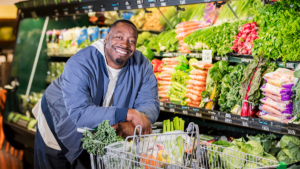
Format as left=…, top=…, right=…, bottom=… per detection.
left=252, top=0, right=300, bottom=62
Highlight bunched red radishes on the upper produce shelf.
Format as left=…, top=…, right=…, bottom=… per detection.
left=232, top=22, right=258, bottom=55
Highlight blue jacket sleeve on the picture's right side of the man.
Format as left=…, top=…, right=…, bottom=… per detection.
left=134, top=61, right=160, bottom=124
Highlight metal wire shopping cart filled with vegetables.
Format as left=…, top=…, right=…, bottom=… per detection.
left=76, top=123, right=286, bottom=169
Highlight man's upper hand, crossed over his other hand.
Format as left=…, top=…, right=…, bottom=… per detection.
left=125, top=109, right=152, bottom=135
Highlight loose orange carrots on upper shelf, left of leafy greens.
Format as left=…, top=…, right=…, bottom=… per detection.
left=175, top=21, right=211, bottom=53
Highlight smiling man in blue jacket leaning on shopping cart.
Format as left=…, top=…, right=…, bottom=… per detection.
left=33, top=20, right=159, bottom=169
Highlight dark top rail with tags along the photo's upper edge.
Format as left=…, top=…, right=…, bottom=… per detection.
left=15, top=0, right=230, bottom=18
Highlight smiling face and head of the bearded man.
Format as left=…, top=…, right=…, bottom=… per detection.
left=104, top=22, right=138, bottom=69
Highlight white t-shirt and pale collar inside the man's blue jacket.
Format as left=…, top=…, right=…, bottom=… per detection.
left=92, top=39, right=121, bottom=107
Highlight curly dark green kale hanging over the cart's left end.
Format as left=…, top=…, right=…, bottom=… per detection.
left=81, top=120, right=124, bottom=155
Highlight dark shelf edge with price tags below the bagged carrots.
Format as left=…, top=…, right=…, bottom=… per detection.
left=160, top=102, right=300, bottom=136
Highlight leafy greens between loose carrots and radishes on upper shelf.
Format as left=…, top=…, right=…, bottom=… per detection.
left=183, top=21, right=245, bottom=56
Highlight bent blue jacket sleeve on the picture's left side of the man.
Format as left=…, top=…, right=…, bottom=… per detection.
left=61, top=60, right=128, bottom=128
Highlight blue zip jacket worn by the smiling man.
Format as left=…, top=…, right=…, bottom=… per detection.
left=45, top=46, right=159, bottom=163
